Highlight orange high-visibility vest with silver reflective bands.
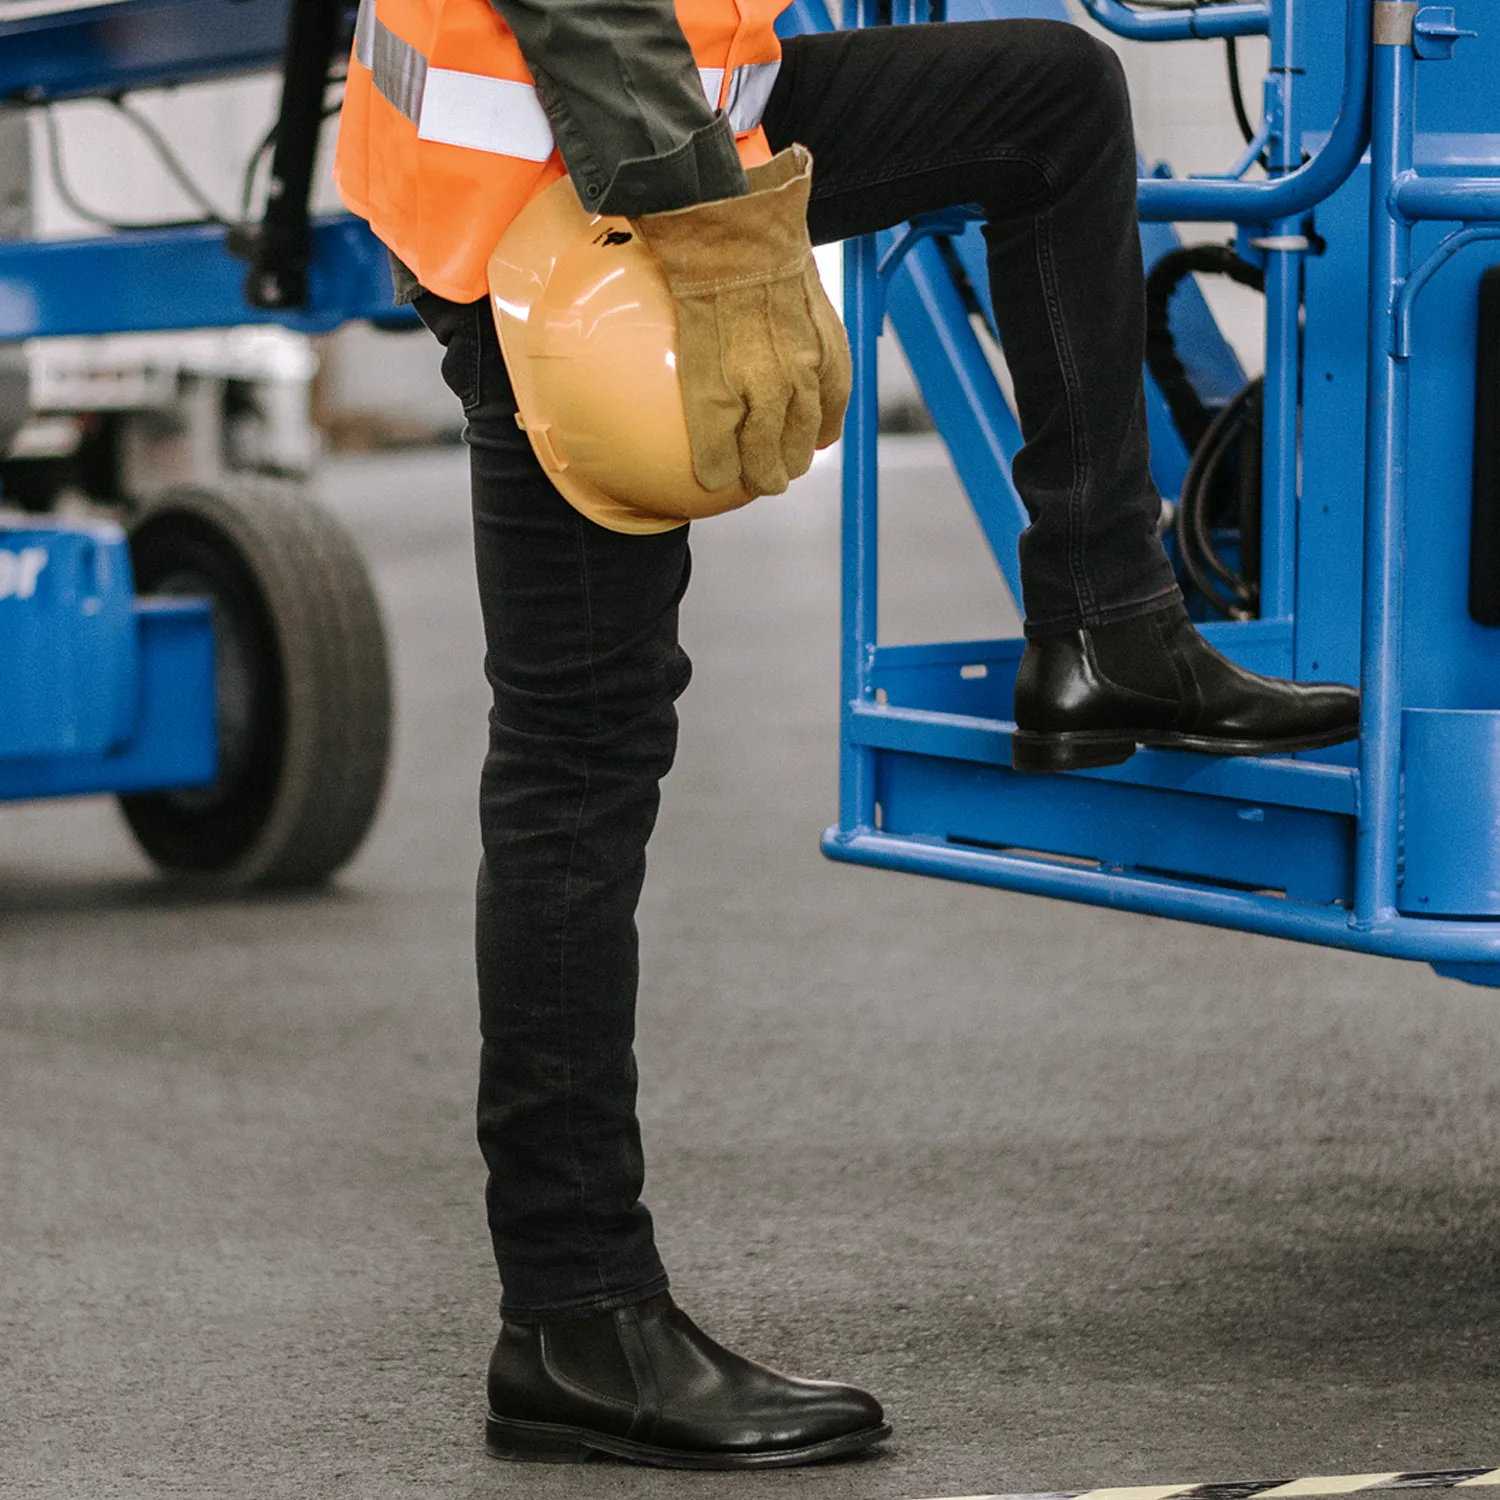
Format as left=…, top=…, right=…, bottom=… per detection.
left=333, top=0, right=786, bottom=302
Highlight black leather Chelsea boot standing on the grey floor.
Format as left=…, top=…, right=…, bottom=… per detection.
left=485, top=1292, right=891, bottom=1469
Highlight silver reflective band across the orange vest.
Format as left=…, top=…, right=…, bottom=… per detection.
left=354, top=0, right=782, bottom=162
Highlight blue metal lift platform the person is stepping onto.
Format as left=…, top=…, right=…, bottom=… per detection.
left=816, top=0, right=1500, bottom=984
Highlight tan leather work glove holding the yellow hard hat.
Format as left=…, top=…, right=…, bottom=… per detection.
left=632, top=146, right=852, bottom=495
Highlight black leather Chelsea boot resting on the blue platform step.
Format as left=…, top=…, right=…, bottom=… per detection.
left=1011, top=600, right=1359, bottom=771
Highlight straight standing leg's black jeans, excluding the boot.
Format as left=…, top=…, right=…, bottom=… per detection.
left=417, top=294, right=689, bottom=1322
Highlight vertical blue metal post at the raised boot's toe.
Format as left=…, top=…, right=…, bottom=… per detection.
left=1355, top=26, right=1415, bottom=929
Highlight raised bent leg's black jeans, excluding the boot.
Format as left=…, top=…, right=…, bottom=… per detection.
left=765, top=21, right=1176, bottom=633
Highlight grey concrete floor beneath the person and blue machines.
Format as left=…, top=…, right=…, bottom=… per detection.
left=0, top=438, right=1500, bottom=1500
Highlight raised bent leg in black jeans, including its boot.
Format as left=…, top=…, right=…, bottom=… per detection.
left=765, top=21, right=1359, bottom=771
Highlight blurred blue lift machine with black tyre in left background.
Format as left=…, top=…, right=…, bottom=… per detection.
left=0, top=0, right=399, bottom=890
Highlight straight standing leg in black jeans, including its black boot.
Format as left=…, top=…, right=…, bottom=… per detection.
left=417, top=294, right=890, bottom=1469
